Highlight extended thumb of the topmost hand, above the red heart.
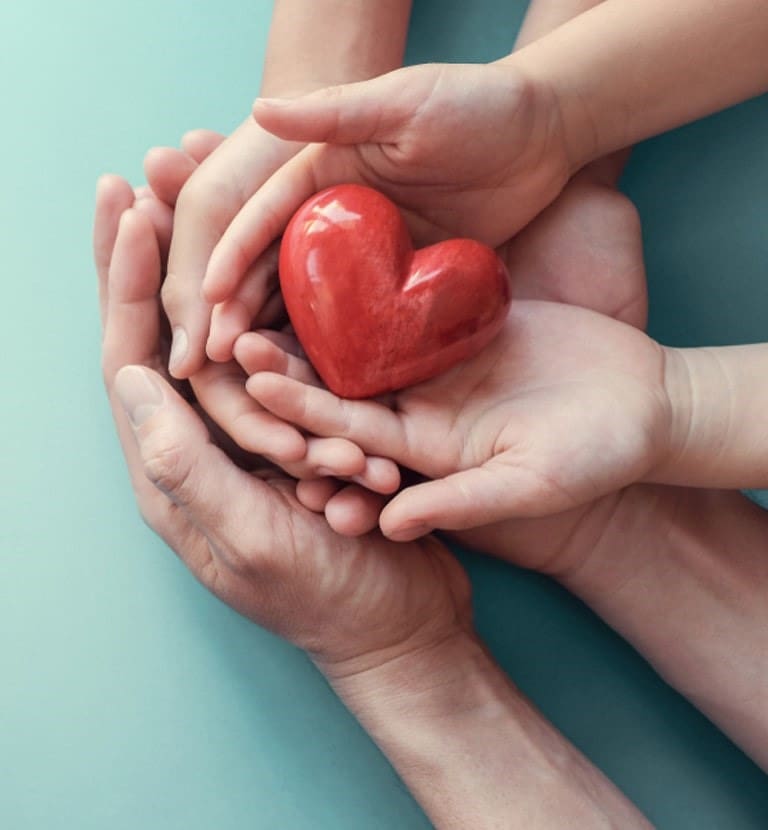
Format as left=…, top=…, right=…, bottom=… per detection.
left=253, top=67, right=433, bottom=144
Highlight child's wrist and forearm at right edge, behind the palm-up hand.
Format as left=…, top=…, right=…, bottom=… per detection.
left=660, top=344, right=768, bottom=489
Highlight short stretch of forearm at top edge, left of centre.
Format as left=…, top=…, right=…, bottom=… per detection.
left=261, top=0, right=411, bottom=95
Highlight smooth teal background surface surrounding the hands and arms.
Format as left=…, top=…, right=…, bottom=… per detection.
left=0, top=0, right=768, bottom=830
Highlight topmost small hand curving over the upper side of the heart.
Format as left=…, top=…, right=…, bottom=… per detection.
left=203, top=64, right=573, bottom=359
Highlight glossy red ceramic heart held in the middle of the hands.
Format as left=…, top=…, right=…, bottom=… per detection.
left=280, top=184, right=510, bottom=398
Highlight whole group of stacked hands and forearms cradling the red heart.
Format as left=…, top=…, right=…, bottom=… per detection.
left=94, top=0, right=768, bottom=828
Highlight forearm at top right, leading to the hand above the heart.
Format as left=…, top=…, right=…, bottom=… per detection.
left=504, top=0, right=768, bottom=169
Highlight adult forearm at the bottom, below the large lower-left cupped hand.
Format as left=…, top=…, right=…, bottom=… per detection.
left=326, top=635, right=650, bottom=830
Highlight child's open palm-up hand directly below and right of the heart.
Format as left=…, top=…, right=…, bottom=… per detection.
left=235, top=301, right=671, bottom=541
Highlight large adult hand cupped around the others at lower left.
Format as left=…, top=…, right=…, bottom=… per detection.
left=94, top=177, right=471, bottom=674
